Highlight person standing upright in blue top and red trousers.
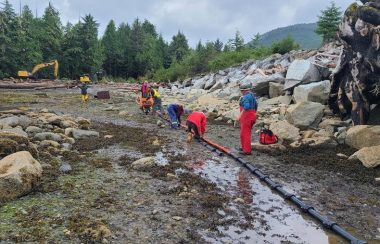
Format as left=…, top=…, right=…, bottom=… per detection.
left=237, top=83, right=257, bottom=155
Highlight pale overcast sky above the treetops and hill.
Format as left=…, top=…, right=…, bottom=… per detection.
left=8, top=0, right=354, bottom=47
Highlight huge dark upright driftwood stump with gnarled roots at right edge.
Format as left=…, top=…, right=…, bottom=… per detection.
left=329, top=0, right=380, bottom=125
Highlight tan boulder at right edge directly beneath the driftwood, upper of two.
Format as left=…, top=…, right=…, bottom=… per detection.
left=346, top=125, right=380, bottom=149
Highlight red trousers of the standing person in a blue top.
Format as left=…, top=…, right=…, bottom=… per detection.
left=240, top=109, right=256, bottom=153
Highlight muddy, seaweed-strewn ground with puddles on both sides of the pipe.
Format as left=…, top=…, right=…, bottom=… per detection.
left=0, top=86, right=380, bottom=243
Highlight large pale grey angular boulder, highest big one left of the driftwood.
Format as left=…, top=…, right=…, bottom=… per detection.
left=284, top=59, right=322, bottom=90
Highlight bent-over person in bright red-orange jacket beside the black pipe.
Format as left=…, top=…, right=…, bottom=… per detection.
left=186, top=111, right=207, bottom=142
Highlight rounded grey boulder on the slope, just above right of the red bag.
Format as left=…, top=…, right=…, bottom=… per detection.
left=285, top=102, right=325, bottom=129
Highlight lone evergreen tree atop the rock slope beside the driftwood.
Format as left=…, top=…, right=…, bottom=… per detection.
left=315, top=2, right=342, bottom=42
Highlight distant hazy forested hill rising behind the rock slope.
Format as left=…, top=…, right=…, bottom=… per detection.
left=254, top=23, right=322, bottom=49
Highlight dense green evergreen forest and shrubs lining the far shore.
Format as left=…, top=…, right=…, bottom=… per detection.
left=0, top=0, right=342, bottom=82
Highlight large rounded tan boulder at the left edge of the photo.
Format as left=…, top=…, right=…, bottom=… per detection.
left=0, top=151, right=42, bottom=202
